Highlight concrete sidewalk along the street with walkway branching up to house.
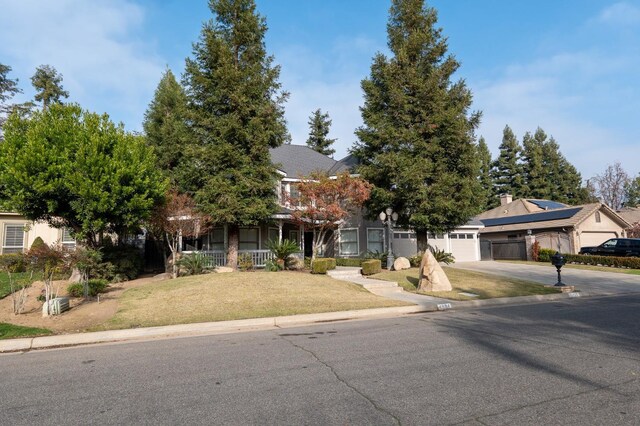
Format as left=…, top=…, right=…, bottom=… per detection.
left=0, top=268, right=599, bottom=353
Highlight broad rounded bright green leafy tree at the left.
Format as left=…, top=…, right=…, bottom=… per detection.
left=0, top=104, right=166, bottom=246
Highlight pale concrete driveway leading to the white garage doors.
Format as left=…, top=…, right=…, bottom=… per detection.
left=449, top=261, right=640, bottom=295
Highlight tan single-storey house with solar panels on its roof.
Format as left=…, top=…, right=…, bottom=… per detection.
left=476, top=195, right=631, bottom=253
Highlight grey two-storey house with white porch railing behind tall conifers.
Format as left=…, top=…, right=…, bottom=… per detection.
left=181, top=145, right=483, bottom=266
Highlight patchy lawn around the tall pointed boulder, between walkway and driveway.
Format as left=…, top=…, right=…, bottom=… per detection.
left=372, top=267, right=560, bottom=300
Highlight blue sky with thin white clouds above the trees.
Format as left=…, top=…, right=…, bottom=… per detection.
left=0, top=0, right=640, bottom=179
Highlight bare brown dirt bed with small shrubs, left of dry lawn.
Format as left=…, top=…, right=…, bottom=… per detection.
left=0, top=277, right=168, bottom=334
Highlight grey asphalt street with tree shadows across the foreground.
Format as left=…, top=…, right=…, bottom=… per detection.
left=0, top=295, right=640, bottom=425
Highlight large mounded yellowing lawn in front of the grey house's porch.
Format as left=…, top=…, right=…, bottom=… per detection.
left=100, top=271, right=408, bottom=330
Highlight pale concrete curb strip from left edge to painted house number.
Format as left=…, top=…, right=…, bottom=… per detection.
left=0, top=304, right=438, bottom=353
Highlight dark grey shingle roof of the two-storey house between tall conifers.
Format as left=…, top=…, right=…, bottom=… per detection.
left=269, top=144, right=338, bottom=178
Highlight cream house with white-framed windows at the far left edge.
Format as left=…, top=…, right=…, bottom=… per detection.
left=0, top=212, right=75, bottom=254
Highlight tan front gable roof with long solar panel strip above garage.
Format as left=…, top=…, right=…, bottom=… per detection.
left=480, top=203, right=629, bottom=233
